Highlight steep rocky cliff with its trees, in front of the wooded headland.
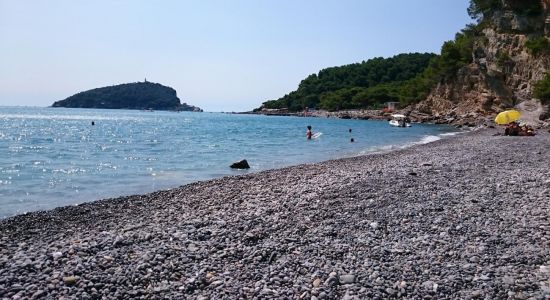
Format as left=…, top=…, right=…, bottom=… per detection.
left=418, top=0, right=550, bottom=121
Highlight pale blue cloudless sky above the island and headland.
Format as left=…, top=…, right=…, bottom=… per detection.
left=0, top=0, right=472, bottom=112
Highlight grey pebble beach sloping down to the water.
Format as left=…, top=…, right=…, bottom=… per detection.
left=0, top=128, right=550, bottom=299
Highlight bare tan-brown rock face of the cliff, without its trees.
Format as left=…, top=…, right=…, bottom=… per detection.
left=414, top=0, right=550, bottom=123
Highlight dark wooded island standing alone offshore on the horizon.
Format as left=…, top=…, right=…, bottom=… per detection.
left=52, top=80, right=202, bottom=111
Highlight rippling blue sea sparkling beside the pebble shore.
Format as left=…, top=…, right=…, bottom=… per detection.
left=0, top=107, right=459, bottom=218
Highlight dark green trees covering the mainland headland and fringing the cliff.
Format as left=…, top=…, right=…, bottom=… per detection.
left=257, top=0, right=550, bottom=112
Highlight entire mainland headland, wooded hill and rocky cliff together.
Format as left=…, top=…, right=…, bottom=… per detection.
left=260, top=0, right=550, bottom=123
